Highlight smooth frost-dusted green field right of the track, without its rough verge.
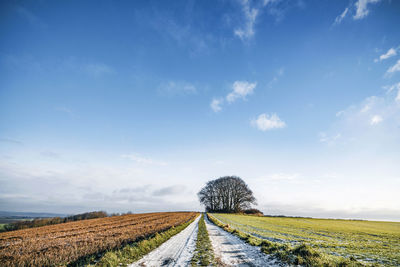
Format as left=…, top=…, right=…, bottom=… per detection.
left=213, top=214, right=400, bottom=266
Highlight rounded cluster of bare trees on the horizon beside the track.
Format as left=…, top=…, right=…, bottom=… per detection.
left=197, top=176, right=256, bottom=213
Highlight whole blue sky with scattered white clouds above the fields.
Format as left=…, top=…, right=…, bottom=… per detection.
left=0, top=0, right=400, bottom=220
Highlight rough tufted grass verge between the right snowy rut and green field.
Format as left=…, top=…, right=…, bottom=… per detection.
left=207, top=214, right=376, bottom=267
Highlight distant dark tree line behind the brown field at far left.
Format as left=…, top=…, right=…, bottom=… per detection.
left=3, top=211, right=108, bottom=231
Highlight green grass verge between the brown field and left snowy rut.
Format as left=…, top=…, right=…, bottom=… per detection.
left=82, top=216, right=197, bottom=266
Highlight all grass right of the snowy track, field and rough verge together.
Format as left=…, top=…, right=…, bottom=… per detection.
left=212, top=214, right=400, bottom=266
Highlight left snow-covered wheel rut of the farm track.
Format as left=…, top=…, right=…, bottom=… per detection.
left=129, top=216, right=201, bottom=267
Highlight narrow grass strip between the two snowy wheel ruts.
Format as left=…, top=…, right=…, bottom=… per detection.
left=191, top=214, right=214, bottom=266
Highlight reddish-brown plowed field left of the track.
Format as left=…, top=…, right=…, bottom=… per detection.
left=0, top=212, right=198, bottom=266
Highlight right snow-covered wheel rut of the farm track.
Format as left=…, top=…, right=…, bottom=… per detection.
left=205, top=217, right=280, bottom=267
